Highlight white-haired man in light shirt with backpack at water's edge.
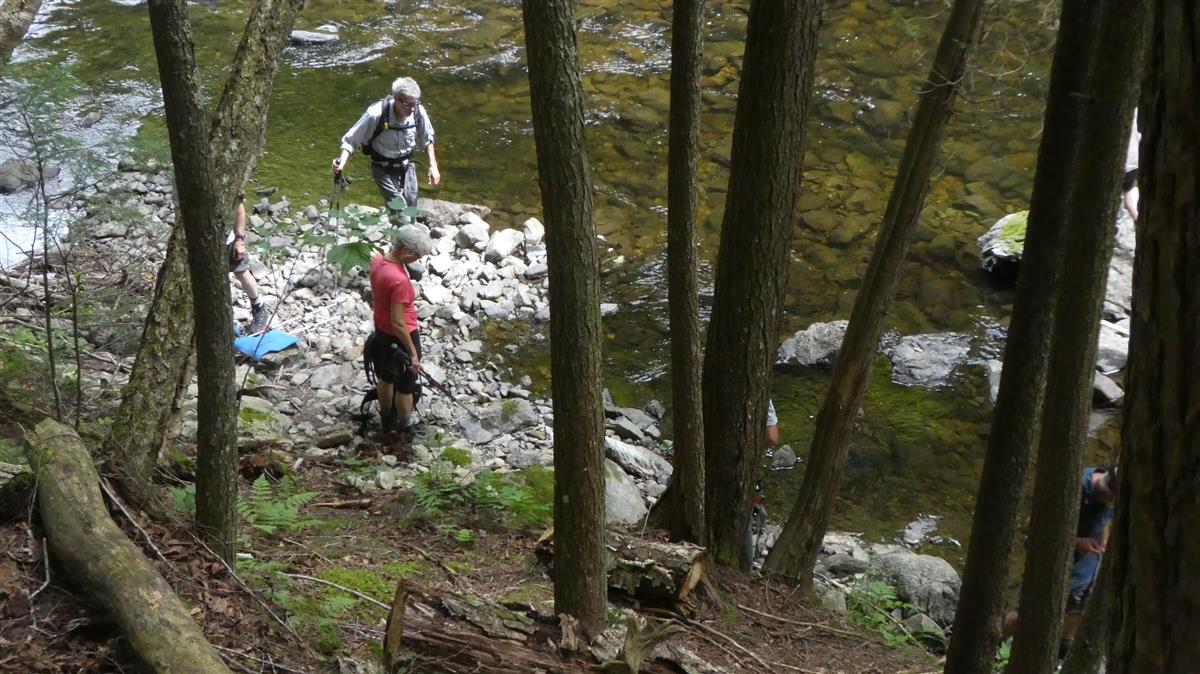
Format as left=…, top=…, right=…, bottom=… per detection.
left=334, top=77, right=442, bottom=221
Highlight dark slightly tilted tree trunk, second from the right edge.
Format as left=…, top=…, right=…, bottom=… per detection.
left=1009, top=2, right=1146, bottom=674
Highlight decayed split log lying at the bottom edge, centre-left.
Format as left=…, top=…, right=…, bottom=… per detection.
left=383, top=580, right=685, bottom=674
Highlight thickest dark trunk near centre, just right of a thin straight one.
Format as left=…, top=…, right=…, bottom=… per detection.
left=703, top=0, right=821, bottom=570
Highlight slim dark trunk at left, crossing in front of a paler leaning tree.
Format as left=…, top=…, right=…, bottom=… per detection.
left=149, top=0, right=238, bottom=561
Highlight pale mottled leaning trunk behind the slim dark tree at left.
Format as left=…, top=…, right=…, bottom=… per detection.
left=104, top=0, right=304, bottom=501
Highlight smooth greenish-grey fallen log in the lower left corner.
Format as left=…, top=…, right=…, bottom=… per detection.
left=25, top=419, right=229, bottom=674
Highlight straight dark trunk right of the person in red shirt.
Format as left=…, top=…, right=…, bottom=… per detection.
left=522, top=0, right=606, bottom=633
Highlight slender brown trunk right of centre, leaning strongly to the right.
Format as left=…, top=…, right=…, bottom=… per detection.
left=766, top=0, right=983, bottom=588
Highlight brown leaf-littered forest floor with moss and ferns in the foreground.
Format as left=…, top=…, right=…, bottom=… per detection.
left=0, top=398, right=940, bottom=674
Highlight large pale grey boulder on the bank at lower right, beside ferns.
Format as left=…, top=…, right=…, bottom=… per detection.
left=866, top=546, right=962, bottom=625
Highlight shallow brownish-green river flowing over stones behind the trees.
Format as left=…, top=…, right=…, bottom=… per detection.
left=0, top=0, right=1103, bottom=562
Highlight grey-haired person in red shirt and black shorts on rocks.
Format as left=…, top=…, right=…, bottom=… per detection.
left=364, top=224, right=433, bottom=433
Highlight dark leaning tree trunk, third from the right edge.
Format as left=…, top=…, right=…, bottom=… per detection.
left=946, top=0, right=1103, bottom=674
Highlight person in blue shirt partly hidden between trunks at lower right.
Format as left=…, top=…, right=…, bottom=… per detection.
left=1003, top=468, right=1120, bottom=658
